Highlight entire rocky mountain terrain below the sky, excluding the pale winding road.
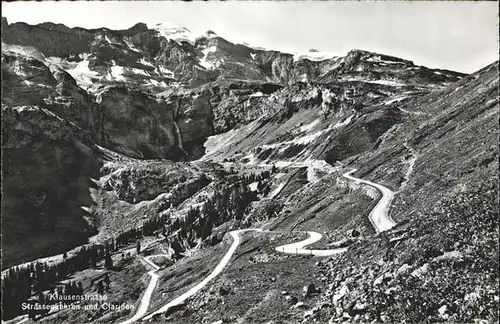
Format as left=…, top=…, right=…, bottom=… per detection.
left=2, top=20, right=499, bottom=323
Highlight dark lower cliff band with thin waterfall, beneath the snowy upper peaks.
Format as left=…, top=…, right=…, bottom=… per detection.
left=2, top=45, right=217, bottom=160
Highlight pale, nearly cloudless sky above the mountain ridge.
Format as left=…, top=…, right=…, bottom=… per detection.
left=2, top=1, right=499, bottom=73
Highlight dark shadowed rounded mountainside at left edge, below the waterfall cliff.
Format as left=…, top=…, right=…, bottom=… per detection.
left=2, top=105, right=100, bottom=267
